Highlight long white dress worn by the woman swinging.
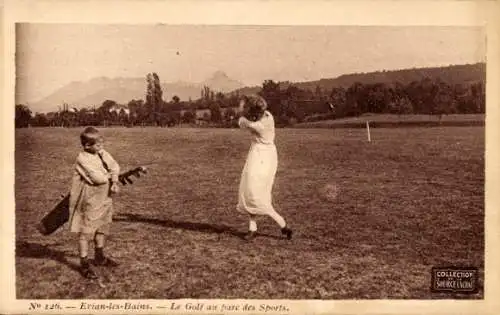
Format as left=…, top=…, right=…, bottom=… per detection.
left=237, top=111, right=278, bottom=215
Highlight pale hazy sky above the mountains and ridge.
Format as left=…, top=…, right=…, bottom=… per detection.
left=16, top=23, right=486, bottom=103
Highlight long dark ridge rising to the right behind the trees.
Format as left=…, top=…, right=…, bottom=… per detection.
left=233, top=63, right=486, bottom=95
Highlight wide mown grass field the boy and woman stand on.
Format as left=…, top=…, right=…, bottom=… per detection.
left=15, top=127, right=484, bottom=299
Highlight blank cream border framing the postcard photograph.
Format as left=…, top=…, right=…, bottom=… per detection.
left=0, top=0, right=500, bottom=314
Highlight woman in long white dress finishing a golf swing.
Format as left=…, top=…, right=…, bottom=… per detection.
left=237, top=96, right=292, bottom=240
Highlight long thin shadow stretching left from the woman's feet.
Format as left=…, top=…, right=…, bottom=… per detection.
left=113, top=213, right=279, bottom=239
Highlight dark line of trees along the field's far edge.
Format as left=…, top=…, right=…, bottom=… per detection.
left=15, top=73, right=485, bottom=128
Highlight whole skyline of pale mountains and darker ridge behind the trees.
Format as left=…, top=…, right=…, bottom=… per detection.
left=30, top=63, right=486, bottom=112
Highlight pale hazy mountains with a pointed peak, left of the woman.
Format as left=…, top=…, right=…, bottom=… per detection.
left=30, top=71, right=243, bottom=112
